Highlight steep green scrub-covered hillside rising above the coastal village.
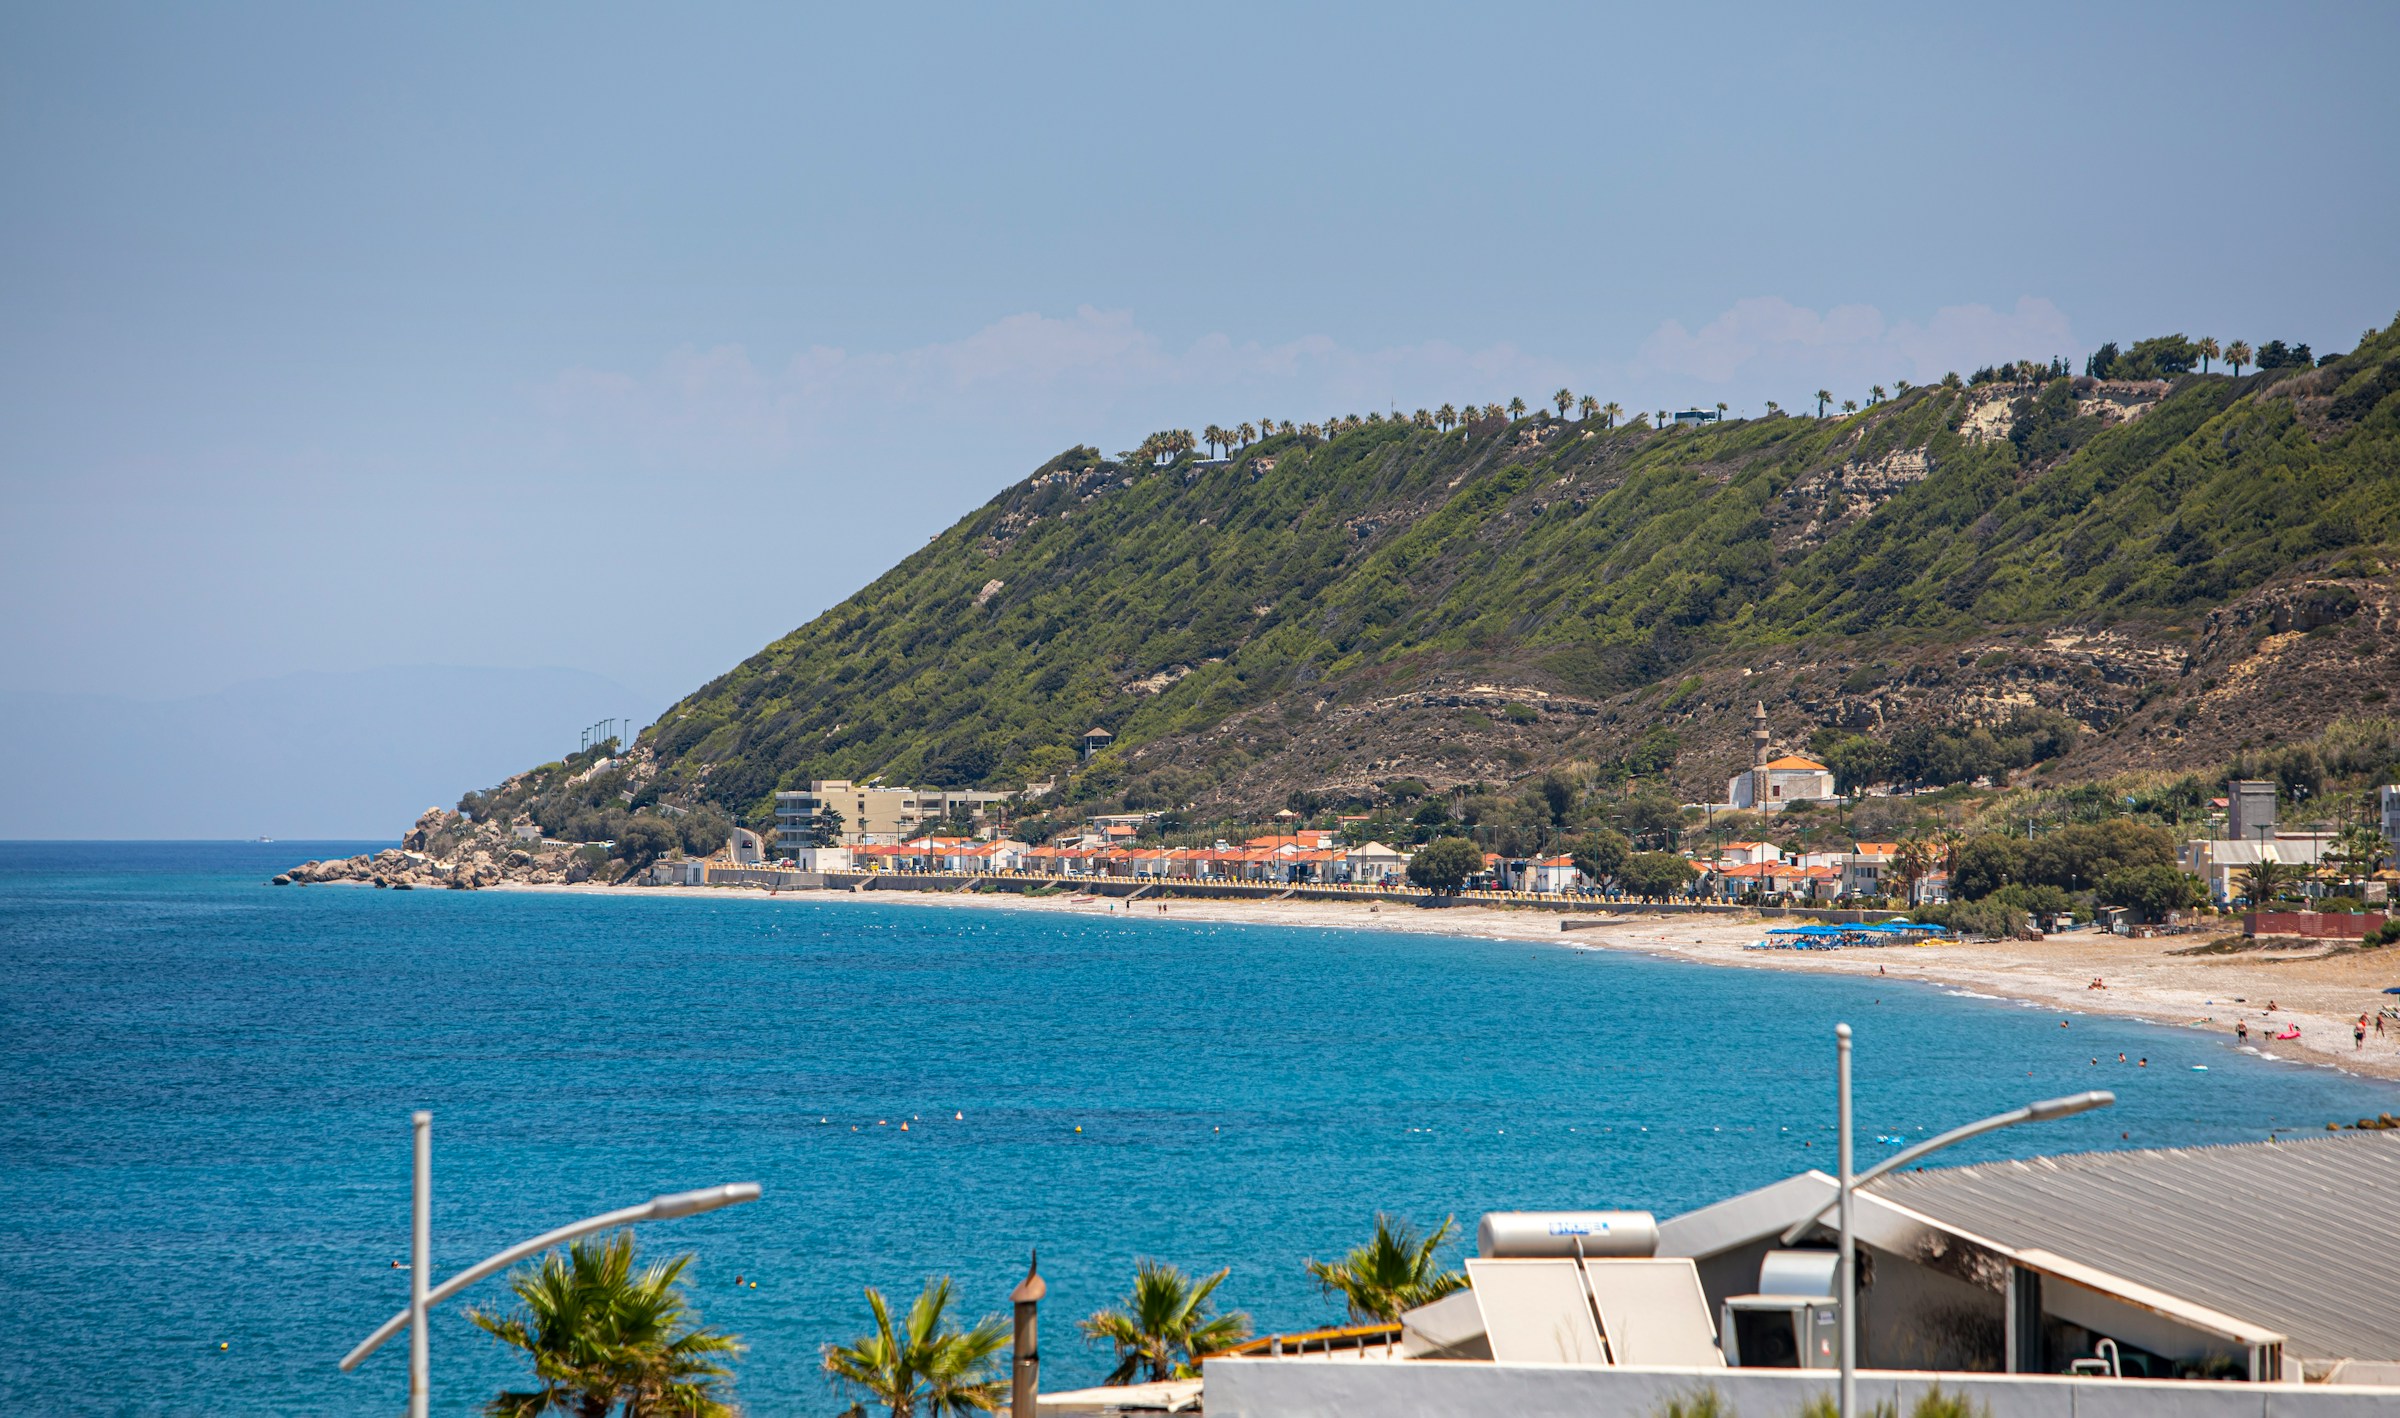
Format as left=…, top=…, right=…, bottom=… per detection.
left=590, top=324, right=2400, bottom=821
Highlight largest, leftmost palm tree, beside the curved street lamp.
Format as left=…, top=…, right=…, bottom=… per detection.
left=468, top=1231, right=742, bottom=1418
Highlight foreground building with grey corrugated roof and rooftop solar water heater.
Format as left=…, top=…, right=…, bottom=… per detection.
left=1209, top=1130, right=2400, bottom=1418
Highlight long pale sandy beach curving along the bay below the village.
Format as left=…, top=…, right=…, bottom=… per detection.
left=482, top=883, right=2400, bottom=1080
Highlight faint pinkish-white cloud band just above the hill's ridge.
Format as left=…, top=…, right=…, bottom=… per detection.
left=538, top=298, right=2074, bottom=468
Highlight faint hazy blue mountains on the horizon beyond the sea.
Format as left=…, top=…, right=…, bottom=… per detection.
left=0, top=665, right=655, bottom=840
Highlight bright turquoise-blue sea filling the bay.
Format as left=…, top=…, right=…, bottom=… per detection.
left=0, top=842, right=2395, bottom=1413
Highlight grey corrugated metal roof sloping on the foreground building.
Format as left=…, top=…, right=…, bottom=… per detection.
left=1872, top=1132, right=2400, bottom=1360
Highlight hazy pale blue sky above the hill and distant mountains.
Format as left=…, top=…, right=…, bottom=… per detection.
left=0, top=2, right=2400, bottom=717
